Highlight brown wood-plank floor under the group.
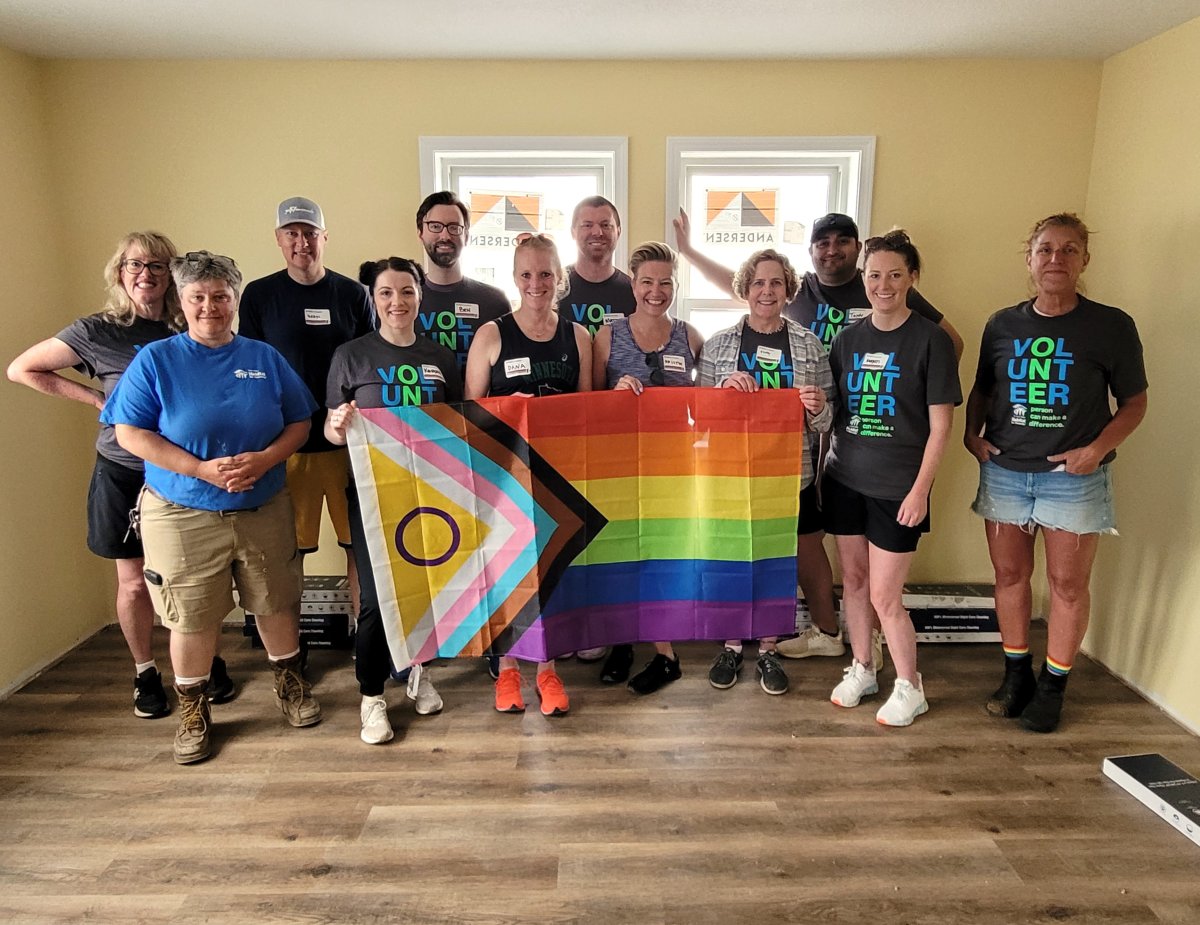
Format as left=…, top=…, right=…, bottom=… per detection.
left=0, top=627, right=1200, bottom=925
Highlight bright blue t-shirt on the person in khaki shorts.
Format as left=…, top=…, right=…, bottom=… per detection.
left=100, top=334, right=317, bottom=511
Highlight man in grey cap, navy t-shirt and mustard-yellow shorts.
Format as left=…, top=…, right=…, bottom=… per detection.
left=238, top=196, right=374, bottom=612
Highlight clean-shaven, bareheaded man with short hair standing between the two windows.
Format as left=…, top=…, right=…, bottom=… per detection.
left=558, top=196, right=637, bottom=337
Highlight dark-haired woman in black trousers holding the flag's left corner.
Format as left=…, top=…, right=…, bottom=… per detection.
left=325, top=257, right=462, bottom=745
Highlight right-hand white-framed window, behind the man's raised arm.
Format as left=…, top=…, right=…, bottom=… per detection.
left=666, top=136, right=875, bottom=337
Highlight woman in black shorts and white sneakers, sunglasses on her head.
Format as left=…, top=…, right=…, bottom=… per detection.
left=821, top=230, right=962, bottom=726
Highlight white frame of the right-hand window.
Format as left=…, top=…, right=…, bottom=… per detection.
left=664, top=136, right=875, bottom=319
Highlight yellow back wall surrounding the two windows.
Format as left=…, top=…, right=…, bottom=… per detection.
left=0, top=54, right=1100, bottom=686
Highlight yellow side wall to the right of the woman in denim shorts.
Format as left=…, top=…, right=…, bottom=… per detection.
left=1085, top=19, right=1200, bottom=729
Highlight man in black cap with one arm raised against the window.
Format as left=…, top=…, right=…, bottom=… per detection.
left=674, top=210, right=962, bottom=358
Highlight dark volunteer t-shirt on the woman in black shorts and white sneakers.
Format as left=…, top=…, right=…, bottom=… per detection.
left=826, top=313, right=962, bottom=500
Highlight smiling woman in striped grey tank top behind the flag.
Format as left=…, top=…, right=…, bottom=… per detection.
left=592, top=241, right=704, bottom=693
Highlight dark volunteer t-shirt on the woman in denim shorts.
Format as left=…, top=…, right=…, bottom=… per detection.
left=976, top=296, right=1146, bottom=471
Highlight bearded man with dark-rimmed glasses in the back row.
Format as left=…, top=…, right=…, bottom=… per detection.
left=416, top=190, right=512, bottom=374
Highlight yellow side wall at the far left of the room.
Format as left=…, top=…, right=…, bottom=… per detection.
left=0, top=48, right=113, bottom=693
